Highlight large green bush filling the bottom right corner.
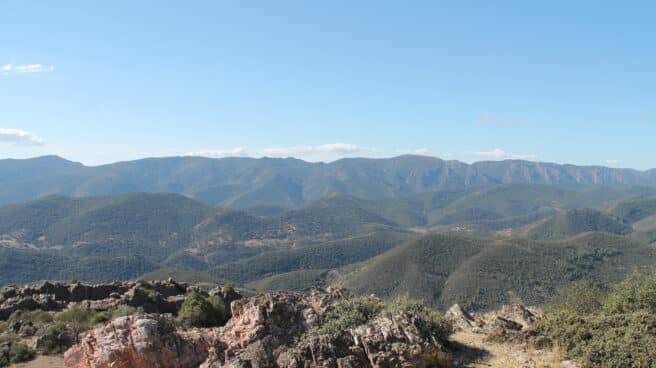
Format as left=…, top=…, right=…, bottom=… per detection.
left=534, top=274, right=656, bottom=368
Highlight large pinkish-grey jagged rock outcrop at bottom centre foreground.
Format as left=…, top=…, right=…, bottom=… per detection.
left=65, top=289, right=446, bottom=368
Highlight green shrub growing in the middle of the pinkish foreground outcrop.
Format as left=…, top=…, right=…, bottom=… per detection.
left=307, top=297, right=384, bottom=336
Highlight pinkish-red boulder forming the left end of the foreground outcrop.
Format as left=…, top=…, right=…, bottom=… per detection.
left=64, top=314, right=213, bottom=368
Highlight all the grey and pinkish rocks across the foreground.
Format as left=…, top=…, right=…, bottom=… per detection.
left=0, top=280, right=573, bottom=368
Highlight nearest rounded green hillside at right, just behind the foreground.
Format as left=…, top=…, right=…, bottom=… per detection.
left=333, top=233, right=656, bottom=309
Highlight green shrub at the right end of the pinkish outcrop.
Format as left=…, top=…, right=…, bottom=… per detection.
left=385, top=294, right=455, bottom=341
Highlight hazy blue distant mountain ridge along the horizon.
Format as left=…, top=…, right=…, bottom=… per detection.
left=0, top=155, right=656, bottom=208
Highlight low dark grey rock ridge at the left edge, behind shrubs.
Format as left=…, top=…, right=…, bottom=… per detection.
left=0, top=279, right=204, bottom=320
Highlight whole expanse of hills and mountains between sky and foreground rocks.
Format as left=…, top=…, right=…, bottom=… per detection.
left=0, top=156, right=656, bottom=309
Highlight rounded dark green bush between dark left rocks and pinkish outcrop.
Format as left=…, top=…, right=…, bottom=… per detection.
left=176, top=291, right=230, bottom=328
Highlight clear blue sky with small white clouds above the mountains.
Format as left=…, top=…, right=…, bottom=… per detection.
left=0, top=0, right=656, bottom=169
